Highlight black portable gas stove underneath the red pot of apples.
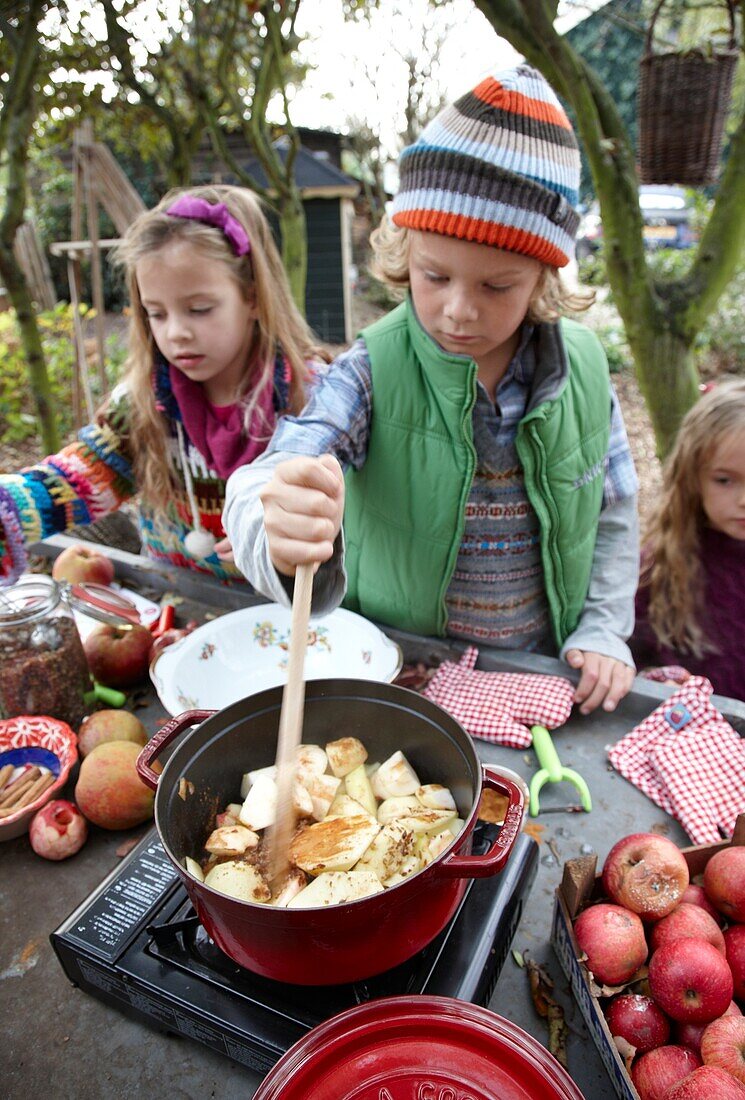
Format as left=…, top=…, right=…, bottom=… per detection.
left=50, top=824, right=537, bottom=1075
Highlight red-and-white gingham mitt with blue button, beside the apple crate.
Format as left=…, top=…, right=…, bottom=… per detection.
left=609, top=677, right=745, bottom=844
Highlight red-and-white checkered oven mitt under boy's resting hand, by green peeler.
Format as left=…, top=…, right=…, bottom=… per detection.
left=423, top=646, right=574, bottom=749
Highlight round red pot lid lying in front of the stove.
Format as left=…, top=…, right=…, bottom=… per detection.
left=254, top=996, right=583, bottom=1100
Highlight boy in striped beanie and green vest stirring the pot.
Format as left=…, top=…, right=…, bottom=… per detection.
left=223, top=65, right=638, bottom=713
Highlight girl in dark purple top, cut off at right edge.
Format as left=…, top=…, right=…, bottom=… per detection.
left=632, top=380, right=745, bottom=700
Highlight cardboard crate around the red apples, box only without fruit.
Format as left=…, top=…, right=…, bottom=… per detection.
left=551, top=814, right=745, bottom=1100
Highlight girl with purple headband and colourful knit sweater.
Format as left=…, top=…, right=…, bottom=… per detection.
left=0, top=186, right=326, bottom=583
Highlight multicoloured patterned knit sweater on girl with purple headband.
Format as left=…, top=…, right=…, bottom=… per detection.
left=0, top=355, right=289, bottom=584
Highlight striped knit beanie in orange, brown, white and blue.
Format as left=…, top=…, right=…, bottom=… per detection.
left=392, top=65, right=580, bottom=267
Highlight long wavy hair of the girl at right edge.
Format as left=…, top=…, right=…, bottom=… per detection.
left=640, top=380, right=745, bottom=657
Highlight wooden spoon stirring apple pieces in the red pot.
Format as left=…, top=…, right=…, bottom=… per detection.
left=267, top=563, right=314, bottom=883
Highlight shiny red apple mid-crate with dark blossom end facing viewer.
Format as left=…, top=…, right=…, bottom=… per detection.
left=649, top=939, right=733, bottom=1024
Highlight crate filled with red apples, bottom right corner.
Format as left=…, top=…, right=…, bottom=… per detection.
left=551, top=814, right=745, bottom=1100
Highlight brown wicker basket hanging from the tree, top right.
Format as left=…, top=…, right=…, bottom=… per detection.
left=638, top=0, right=737, bottom=187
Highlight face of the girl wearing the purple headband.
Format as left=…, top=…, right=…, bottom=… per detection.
left=135, top=241, right=256, bottom=405
